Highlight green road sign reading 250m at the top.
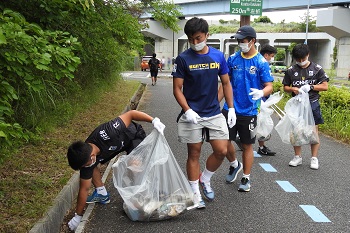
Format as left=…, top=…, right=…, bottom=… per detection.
left=230, top=0, right=263, bottom=15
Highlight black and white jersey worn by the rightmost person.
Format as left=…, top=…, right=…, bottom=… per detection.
left=282, top=62, right=329, bottom=102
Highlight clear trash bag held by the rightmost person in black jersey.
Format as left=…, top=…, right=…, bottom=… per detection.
left=275, top=92, right=319, bottom=146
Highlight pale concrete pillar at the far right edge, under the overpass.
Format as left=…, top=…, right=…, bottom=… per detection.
left=337, top=37, right=350, bottom=77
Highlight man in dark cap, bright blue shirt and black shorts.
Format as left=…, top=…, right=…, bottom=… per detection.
left=219, top=25, right=273, bottom=192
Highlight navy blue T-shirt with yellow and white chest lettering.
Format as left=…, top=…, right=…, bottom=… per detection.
left=171, top=46, right=229, bottom=117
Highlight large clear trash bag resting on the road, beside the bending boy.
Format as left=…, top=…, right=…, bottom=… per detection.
left=112, top=129, right=193, bottom=221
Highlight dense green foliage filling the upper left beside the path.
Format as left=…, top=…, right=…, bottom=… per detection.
left=0, top=0, right=180, bottom=157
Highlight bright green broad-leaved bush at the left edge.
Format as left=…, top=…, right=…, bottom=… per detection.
left=0, top=9, right=80, bottom=145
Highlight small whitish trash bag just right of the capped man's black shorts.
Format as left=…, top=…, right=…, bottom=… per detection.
left=256, top=92, right=283, bottom=141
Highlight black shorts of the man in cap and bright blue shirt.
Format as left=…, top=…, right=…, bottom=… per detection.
left=222, top=109, right=257, bottom=144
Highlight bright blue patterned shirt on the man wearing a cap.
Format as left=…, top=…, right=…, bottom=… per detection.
left=223, top=51, right=273, bottom=116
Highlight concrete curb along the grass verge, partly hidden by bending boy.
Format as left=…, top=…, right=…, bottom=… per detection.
left=29, top=83, right=146, bottom=233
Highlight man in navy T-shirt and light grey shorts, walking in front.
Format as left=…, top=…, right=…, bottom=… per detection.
left=172, top=17, right=236, bottom=208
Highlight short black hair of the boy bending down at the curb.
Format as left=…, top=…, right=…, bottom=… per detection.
left=67, top=141, right=92, bottom=170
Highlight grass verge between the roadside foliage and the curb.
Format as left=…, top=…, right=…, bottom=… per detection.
left=0, top=79, right=139, bottom=233
